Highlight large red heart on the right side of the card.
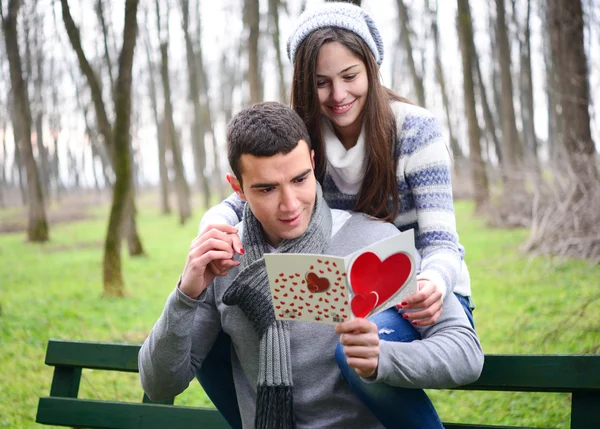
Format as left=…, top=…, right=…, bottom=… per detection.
left=350, top=252, right=412, bottom=304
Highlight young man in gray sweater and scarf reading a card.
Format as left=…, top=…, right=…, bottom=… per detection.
left=139, top=103, right=483, bottom=429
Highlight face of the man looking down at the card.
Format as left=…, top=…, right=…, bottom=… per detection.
left=228, top=140, right=317, bottom=247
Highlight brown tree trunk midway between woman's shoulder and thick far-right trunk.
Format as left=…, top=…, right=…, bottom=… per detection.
left=458, top=0, right=489, bottom=212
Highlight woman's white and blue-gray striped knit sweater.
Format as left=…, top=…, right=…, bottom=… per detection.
left=200, top=102, right=471, bottom=296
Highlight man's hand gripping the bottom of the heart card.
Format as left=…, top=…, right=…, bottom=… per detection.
left=335, top=318, right=379, bottom=377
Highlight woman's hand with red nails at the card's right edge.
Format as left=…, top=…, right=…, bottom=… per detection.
left=396, top=279, right=443, bottom=326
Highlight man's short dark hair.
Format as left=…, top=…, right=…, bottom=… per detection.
left=227, top=101, right=311, bottom=183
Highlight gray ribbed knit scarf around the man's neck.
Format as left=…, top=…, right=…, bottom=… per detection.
left=223, top=183, right=332, bottom=429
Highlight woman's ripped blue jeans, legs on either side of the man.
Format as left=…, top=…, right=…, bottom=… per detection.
left=196, top=295, right=475, bottom=429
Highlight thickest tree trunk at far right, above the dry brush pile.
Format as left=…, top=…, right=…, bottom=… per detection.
left=547, top=0, right=598, bottom=190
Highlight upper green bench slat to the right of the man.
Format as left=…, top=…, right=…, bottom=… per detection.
left=456, top=355, right=600, bottom=392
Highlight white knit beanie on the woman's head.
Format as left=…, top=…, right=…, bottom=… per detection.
left=287, top=2, right=383, bottom=65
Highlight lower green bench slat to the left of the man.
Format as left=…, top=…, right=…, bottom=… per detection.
left=36, top=397, right=229, bottom=429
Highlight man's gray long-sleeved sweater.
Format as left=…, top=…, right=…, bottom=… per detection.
left=139, top=214, right=483, bottom=429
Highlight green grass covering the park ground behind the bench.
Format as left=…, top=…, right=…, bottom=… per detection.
left=0, top=202, right=600, bottom=428
